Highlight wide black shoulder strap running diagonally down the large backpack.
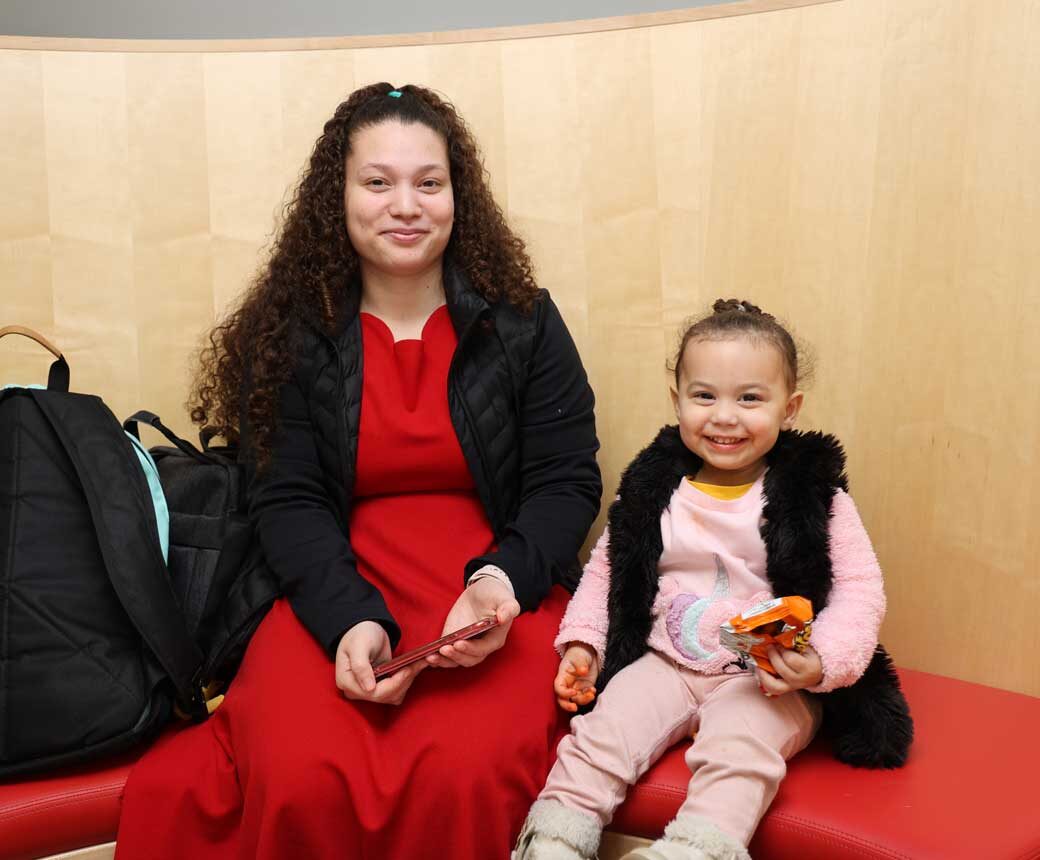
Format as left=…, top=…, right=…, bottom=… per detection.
left=28, top=390, right=206, bottom=719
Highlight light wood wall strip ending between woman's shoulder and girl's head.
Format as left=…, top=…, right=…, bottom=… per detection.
left=575, top=30, right=664, bottom=490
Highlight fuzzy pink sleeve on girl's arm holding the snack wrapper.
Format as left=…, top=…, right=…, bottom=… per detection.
left=809, top=490, right=885, bottom=693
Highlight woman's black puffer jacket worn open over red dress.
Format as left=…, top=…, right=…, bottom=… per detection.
left=250, top=266, right=601, bottom=653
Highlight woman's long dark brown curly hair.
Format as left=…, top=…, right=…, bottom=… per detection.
left=188, top=82, right=537, bottom=466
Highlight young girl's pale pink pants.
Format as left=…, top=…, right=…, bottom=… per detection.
left=539, top=651, right=820, bottom=845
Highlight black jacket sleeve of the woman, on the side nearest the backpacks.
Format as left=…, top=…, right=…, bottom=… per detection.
left=249, top=359, right=400, bottom=654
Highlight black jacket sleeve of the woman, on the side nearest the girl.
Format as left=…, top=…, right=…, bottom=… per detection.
left=466, top=294, right=602, bottom=609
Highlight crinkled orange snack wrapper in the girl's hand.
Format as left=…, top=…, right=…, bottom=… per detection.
left=719, top=595, right=812, bottom=675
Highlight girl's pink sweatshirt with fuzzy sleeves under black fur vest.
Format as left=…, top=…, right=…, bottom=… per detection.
left=555, top=477, right=885, bottom=693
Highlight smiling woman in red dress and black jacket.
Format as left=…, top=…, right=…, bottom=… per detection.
left=118, top=83, right=601, bottom=860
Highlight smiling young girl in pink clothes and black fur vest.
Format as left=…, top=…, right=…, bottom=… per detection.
left=513, top=299, right=913, bottom=860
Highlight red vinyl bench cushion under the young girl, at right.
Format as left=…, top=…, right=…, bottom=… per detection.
left=609, top=670, right=1040, bottom=860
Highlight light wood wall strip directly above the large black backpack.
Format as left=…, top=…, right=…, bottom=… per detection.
left=43, top=53, right=141, bottom=413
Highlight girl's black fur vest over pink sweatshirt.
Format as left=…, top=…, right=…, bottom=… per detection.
left=597, top=426, right=913, bottom=767
